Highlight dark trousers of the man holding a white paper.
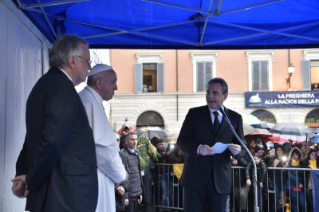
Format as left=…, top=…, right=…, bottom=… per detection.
left=184, top=177, right=228, bottom=212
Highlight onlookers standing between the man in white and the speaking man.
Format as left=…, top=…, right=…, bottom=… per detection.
left=115, top=131, right=184, bottom=212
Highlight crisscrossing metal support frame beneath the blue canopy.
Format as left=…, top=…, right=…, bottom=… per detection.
left=17, top=0, right=319, bottom=46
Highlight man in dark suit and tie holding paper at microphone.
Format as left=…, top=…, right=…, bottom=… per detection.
left=177, top=78, right=244, bottom=212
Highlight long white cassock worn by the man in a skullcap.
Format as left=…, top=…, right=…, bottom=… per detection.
left=79, top=86, right=126, bottom=212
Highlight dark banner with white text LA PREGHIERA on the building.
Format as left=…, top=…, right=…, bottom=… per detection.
left=245, top=91, right=319, bottom=108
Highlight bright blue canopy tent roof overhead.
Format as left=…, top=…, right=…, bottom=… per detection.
left=13, top=0, right=319, bottom=49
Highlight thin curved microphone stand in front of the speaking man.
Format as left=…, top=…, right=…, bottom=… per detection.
left=217, top=105, right=259, bottom=212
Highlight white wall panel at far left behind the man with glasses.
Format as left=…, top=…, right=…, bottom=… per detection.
left=0, top=0, right=50, bottom=212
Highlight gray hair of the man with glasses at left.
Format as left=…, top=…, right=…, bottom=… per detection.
left=50, top=34, right=89, bottom=68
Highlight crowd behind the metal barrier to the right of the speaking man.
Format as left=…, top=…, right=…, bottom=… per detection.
left=231, top=138, right=318, bottom=212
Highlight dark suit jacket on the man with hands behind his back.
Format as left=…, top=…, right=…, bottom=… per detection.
left=16, top=68, right=98, bottom=212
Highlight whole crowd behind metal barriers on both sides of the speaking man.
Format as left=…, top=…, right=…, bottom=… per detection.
left=119, top=130, right=318, bottom=212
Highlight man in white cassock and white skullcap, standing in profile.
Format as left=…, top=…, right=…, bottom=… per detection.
left=79, top=64, right=126, bottom=212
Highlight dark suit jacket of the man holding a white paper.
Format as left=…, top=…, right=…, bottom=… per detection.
left=177, top=105, right=244, bottom=194
